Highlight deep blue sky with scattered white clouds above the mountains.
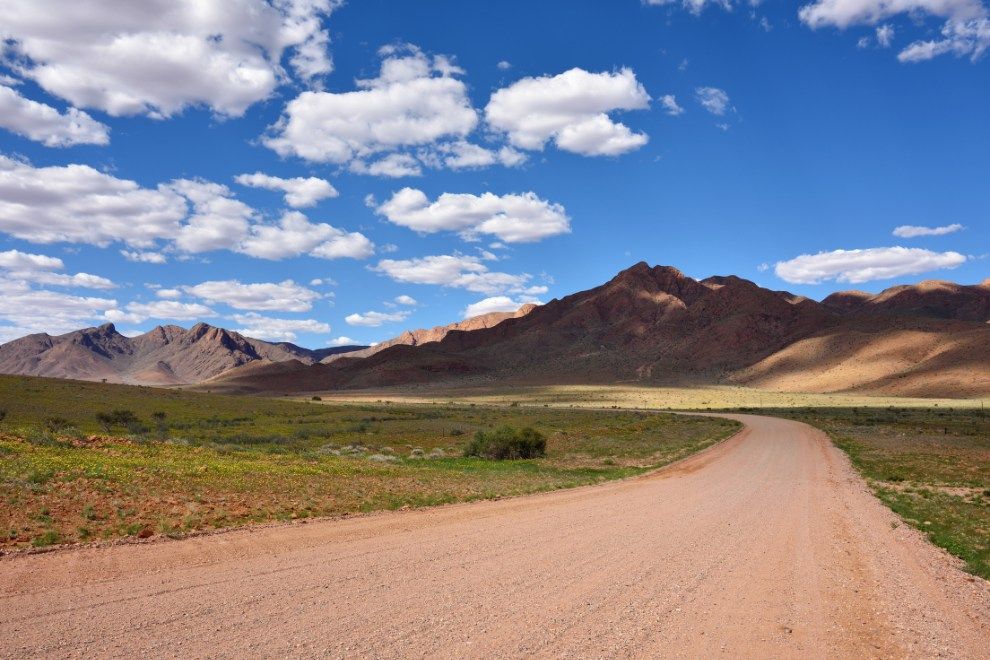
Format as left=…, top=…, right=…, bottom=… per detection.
left=0, top=0, right=990, bottom=347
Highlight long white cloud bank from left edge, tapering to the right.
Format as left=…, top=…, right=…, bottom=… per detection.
left=0, top=156, right=374, bottom=264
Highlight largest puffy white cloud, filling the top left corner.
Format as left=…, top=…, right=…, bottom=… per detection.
left=0, top=0, right=339, bottom=117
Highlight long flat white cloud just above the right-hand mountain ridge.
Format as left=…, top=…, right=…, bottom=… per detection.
left=774, top=247, right=966, bottom=284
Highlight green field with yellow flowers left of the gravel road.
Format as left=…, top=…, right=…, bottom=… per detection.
left=0, top=376, right=738, bottom=547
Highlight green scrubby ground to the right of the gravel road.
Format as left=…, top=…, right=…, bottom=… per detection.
left=761, top=406, right=990, bottom=579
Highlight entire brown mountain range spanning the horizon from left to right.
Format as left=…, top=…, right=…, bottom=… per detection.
left=0, top=263, right=990, bottom=397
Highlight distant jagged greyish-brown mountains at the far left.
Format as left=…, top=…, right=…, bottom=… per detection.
left=0, top=323, right=366, bottom=385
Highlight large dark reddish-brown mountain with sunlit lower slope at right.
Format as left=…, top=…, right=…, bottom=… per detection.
left=205, top=263, right=990, bottom=396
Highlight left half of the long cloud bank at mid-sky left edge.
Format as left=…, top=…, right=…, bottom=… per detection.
left=0, top=155, right=187, bottom=247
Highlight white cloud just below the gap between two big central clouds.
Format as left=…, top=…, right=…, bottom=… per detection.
left=375, top=188, right=570, bottom=243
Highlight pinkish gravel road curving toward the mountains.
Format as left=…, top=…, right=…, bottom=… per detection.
left=0, top=415, right=990, bottom=658
